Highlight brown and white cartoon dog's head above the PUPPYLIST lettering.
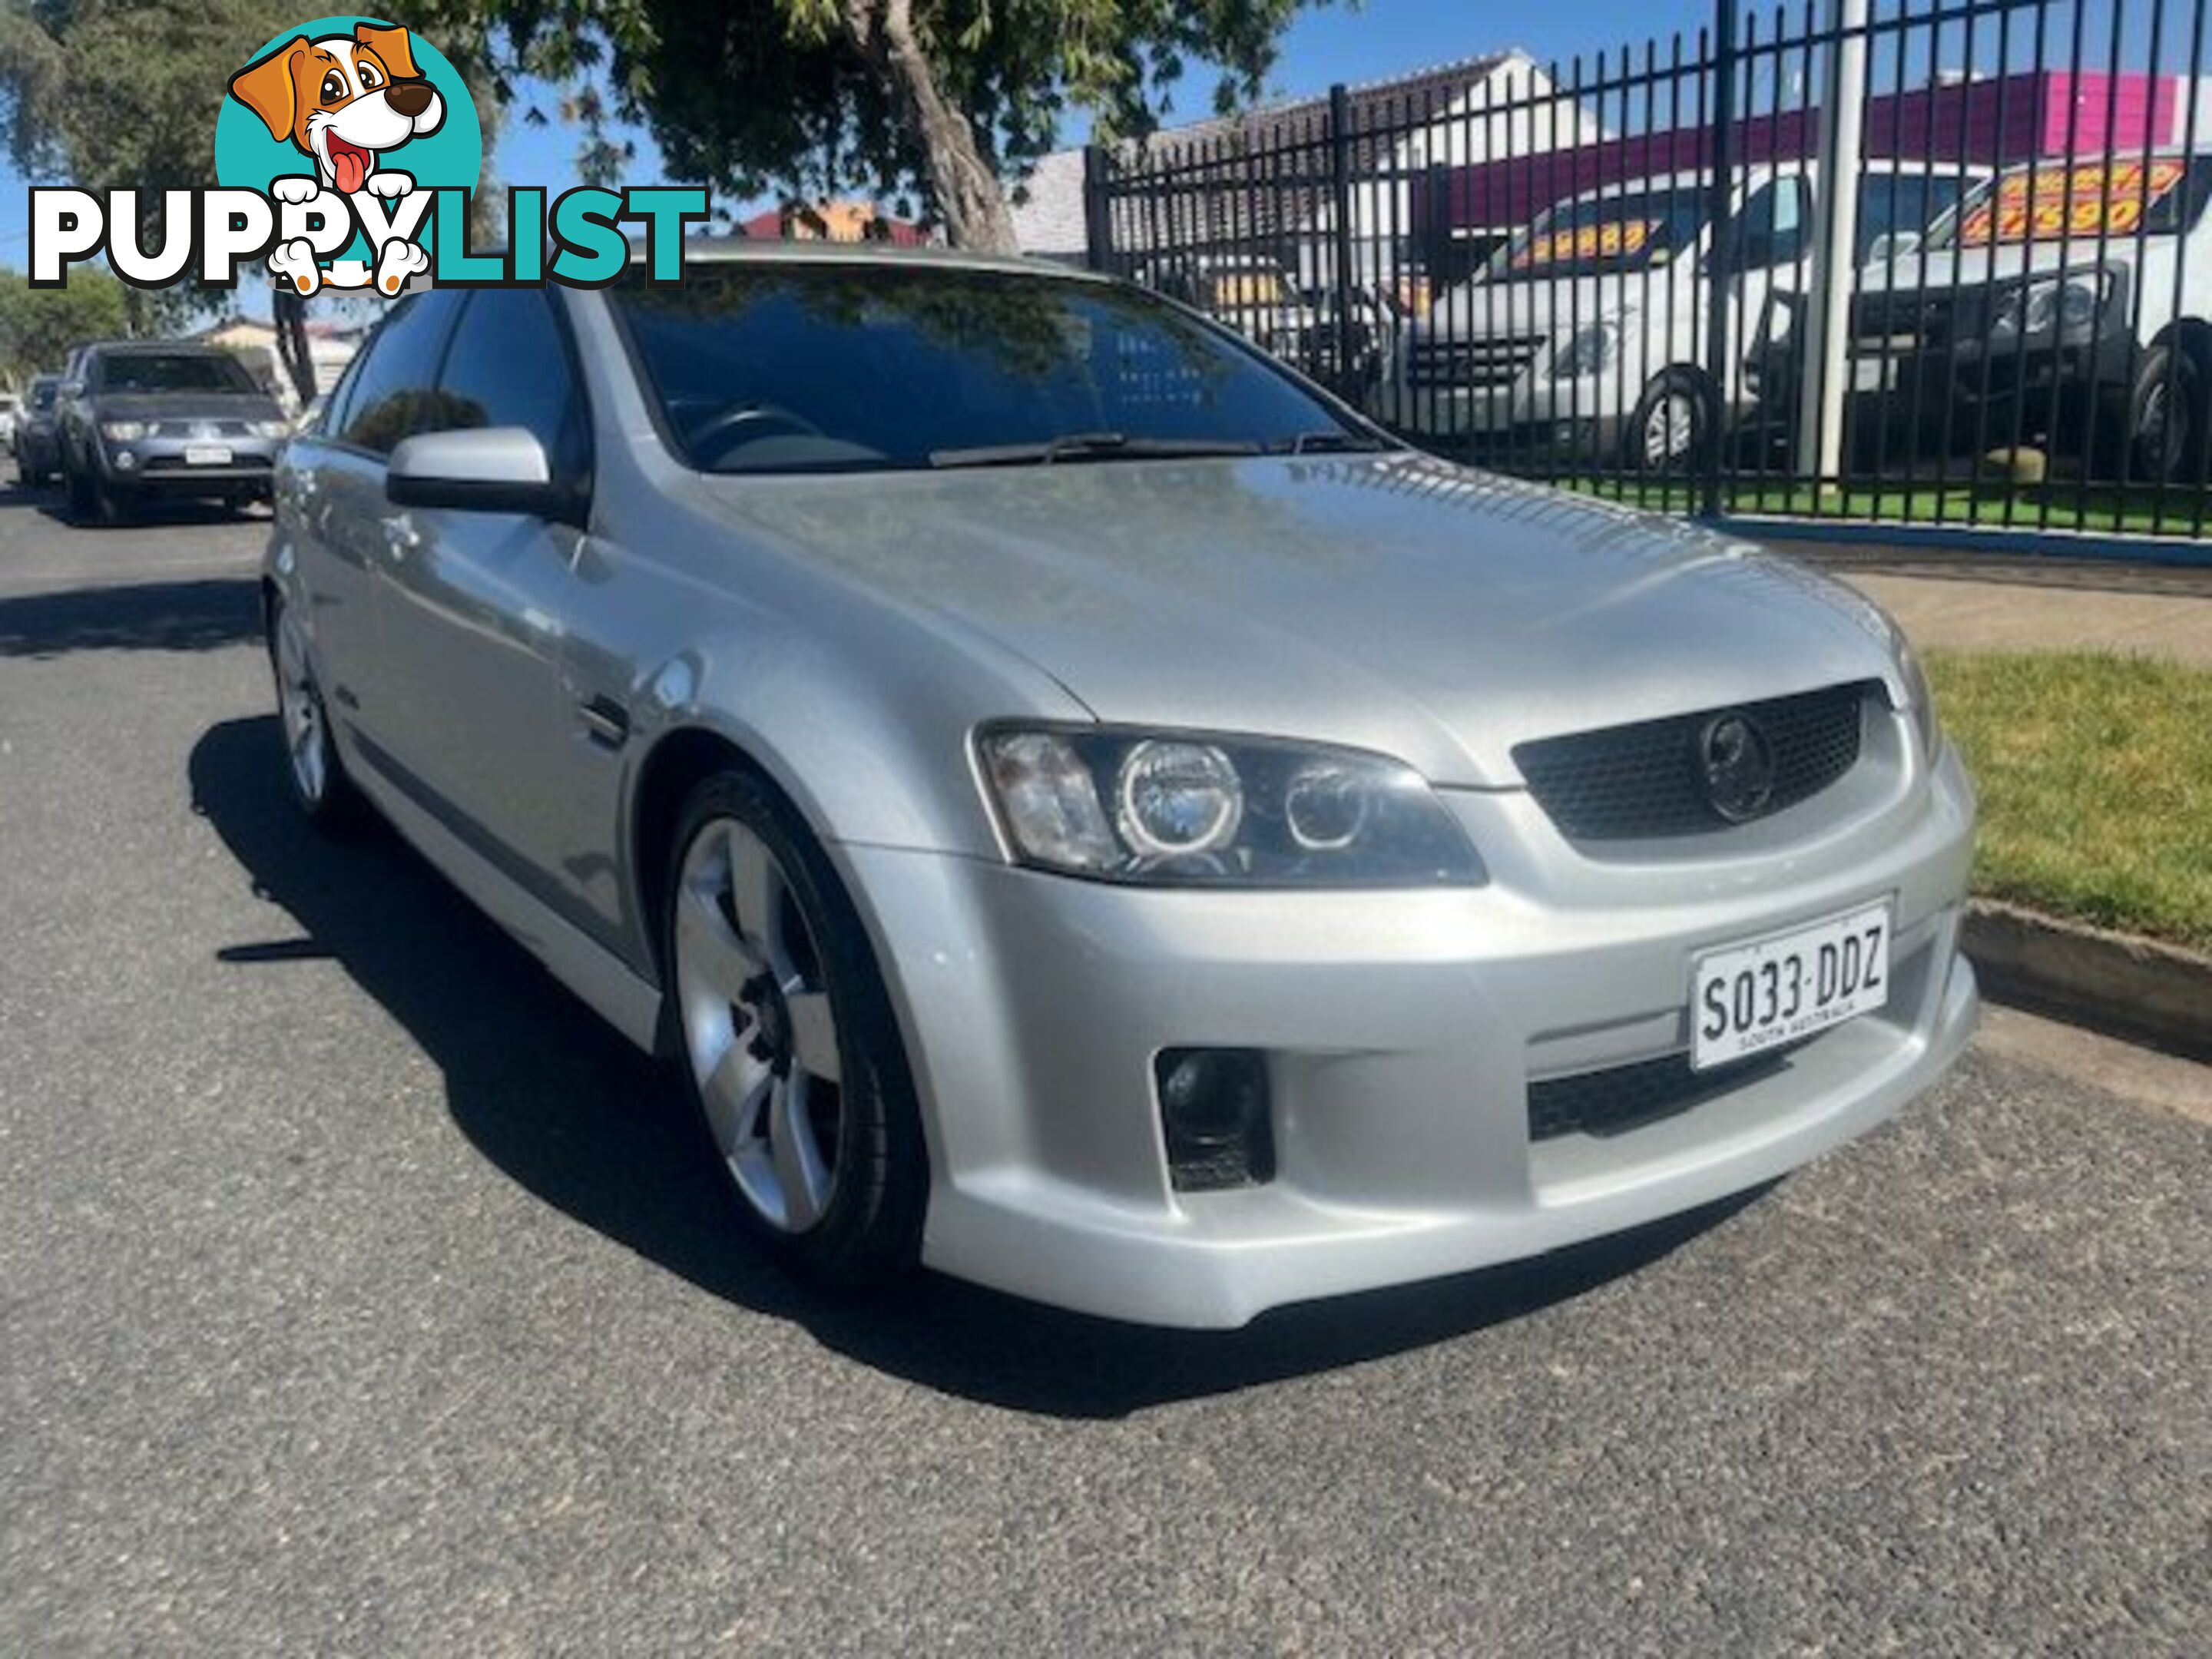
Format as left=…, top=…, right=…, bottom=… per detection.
left=230, top=22, right=445, bottom=194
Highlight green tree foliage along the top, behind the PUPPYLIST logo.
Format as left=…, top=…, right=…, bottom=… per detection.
left=0, top=0, right=1307, bottom=250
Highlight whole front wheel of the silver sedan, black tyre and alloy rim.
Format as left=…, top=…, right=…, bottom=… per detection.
left=661, top=772, right=929, bottom=1292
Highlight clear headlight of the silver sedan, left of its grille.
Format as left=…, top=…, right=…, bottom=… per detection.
left=978, top=726, right=1482, bottom=887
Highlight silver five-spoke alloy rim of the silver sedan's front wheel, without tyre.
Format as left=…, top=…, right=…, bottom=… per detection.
left=673, top=819, right=843, bottom=1234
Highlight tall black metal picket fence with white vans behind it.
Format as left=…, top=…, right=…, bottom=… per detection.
left=1086, top=0, right=2212, bottom=535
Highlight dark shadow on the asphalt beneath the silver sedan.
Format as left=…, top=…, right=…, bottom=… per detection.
left=190, top=717, right=1750, bottom=1418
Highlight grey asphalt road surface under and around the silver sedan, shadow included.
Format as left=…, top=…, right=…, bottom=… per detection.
left=0, top=473, right=2212, bottom=1657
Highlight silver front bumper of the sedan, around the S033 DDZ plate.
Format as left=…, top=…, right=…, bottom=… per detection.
left=839, top=752, right=1978, bottom=1327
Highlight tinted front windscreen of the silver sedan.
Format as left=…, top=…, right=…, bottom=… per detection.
left=613, top=261, right=1369, bottom=471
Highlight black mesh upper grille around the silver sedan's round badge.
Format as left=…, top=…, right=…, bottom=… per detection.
left=1513, top=679, right=1880, bottom=840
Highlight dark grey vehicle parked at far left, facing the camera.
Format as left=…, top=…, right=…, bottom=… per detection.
left=55, top=341, right=292, bottom=522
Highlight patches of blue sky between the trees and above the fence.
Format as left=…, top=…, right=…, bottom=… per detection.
left=0, top=0, right=1712, bottom=310
